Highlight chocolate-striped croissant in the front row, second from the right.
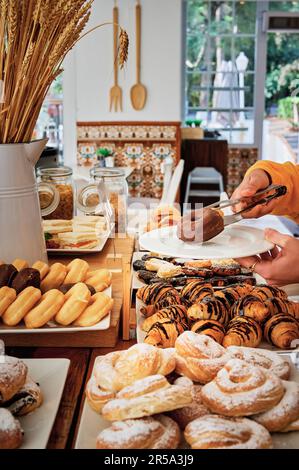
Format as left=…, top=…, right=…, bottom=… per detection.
left=222, top=316, right=262, bottom=348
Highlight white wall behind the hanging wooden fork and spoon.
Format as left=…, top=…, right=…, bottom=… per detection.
left=64, top=0, right=182, bottom=161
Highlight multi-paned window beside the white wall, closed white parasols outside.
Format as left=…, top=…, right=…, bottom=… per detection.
left=185, top=0, right=257, bottom=144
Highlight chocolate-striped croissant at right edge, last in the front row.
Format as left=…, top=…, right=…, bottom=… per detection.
left=264, top=313, right=299, bottom=349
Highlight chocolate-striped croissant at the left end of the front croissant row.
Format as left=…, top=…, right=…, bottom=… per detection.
left=144, top=318, right=189, bottom=348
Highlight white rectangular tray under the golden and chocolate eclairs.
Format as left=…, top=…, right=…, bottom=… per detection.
left=0, top=286, right=112, bottom=335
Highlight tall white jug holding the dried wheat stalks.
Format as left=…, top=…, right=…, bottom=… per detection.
left=0, top=139, right=47, bottom=265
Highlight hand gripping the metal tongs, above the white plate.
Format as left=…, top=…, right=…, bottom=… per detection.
left=231, top=169, right=277, bottom=219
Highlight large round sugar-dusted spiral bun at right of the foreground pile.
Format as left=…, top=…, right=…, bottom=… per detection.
left=201, top=359, right=284, bottom=416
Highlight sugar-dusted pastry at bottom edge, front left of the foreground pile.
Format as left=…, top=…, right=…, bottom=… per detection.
left=96, top=415, right=181, bottom=449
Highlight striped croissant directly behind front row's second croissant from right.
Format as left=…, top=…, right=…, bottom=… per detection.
left=231, top=294, right=270, bottom=323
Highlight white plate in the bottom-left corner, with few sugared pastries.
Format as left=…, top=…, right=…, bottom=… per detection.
left=19, top=359, right=70, bottom=449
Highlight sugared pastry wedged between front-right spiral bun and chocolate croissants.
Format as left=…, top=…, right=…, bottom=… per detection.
left=227, top=346, right=291, bottom=380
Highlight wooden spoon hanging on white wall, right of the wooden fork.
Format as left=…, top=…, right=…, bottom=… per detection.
left=131, top=1, right=147, bottom=111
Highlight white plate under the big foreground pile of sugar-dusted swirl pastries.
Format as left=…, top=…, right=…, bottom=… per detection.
left=75, top=358, right=299, bottom=449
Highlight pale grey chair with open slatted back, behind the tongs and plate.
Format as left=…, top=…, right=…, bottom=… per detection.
left=184, top=167, right=224, bottom=204
